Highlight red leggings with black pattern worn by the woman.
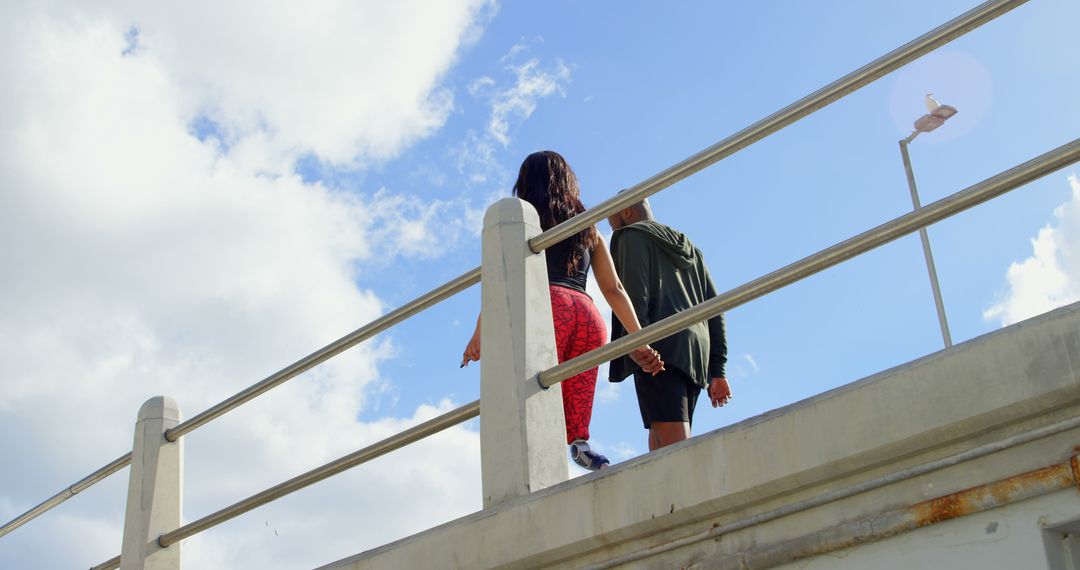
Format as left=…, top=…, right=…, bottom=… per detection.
left=550, top=285, right=607, bottom=444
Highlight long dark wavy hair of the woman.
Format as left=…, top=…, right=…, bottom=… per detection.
left=514, top=150, right=600, bottom=275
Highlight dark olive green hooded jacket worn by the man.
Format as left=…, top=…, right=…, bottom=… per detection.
left=608, top=220, right=728, bottom=388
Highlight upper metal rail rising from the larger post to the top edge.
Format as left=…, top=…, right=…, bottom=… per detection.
left=529, top=0, right=1027, bottom=253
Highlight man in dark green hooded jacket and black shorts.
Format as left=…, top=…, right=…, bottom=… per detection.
left=608, top=200, right=731, bottom=451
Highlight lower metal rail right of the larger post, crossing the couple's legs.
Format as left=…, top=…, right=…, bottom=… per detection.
left=537, top=138, right=1080, bottom=388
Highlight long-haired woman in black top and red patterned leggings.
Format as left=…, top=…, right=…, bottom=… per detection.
left=462, top=150, right=663, bottom=471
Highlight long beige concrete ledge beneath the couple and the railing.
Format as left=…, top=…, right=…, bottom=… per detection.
left=324, top=303, right=1080, bottom=569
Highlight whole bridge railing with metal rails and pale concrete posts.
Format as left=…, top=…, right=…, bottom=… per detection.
left=0, top=0, right=1080, bottom=569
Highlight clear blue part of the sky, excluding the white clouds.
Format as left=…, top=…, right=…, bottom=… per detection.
left=361, top=1, right=1080, bottom=452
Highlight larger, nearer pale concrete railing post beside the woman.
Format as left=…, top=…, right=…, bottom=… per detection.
left=480, top=198, right=569, bottom=508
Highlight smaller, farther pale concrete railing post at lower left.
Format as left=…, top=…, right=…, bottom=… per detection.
left=120, top=396, right=184, bottom=570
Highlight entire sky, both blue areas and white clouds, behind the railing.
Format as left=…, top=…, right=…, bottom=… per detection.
left=0, top=0, right=1080, bottom=568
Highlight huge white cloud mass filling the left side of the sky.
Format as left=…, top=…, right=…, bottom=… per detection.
left=0, top=1, right=486, bottom=568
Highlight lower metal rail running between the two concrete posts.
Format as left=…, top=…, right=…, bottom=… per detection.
left=93, top=399, right=480, bottom=570
